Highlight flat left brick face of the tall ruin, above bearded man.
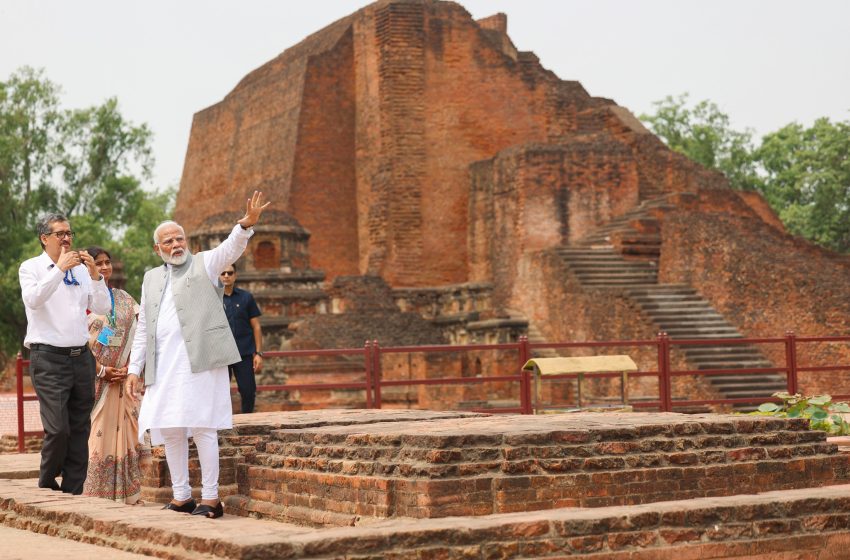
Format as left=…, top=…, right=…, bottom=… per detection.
left=175, top=14, right=351, bottom=253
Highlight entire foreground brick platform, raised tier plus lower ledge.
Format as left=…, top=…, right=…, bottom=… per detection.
left=0, top=410, right=850, bottom=560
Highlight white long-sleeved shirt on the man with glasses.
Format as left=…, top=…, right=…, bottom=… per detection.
left=18, top=252, right=112, bottom=348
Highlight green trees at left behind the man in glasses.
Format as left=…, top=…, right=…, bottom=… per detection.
left=0, top=67, right=175, bottom=365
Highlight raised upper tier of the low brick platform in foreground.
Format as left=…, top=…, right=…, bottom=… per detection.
left=214, top=411, right=850, bottom=525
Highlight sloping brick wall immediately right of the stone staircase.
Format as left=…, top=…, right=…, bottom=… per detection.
left=659, top=191, right=850, bottom=394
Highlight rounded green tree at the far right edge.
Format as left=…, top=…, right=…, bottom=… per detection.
left=756, top=118, right=850, bottom=252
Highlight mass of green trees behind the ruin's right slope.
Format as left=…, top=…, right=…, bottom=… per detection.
left=641, top=94, right=850, bottom=252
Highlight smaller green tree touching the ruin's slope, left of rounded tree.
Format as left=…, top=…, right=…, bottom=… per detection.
left=640, top=93, right=761, bottom=190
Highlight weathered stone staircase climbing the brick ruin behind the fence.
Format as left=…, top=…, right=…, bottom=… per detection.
left=557, top=205, right=787, bottom=411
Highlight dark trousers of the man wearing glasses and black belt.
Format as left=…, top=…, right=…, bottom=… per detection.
left=30, top=345, right=95, bottom=494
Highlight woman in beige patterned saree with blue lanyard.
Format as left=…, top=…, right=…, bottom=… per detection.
left=83, top=247, right=150, bottom=504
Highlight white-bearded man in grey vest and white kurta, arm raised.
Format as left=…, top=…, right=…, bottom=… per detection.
left=127, top=191, right=270, bottom=518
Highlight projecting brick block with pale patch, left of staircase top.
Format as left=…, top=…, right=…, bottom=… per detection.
left=469, top=139, right=639, bottom=309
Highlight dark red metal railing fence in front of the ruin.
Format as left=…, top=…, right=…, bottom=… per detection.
left=16, top=331, right=850, bottom=453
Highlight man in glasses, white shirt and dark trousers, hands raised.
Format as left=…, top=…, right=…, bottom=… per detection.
left=18, top=214, right=111, bottom=494
